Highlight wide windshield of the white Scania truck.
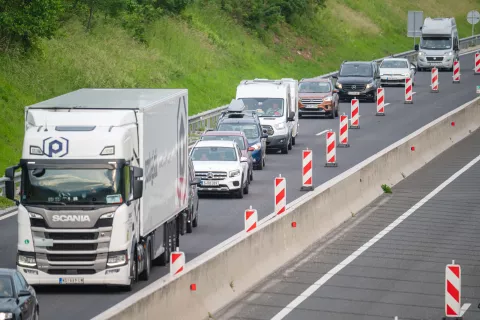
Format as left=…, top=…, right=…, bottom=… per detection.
left=21, top=168, right=123, bottom=204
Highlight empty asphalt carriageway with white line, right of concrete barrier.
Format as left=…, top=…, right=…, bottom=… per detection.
left=214, top=116, right=480, bottom=320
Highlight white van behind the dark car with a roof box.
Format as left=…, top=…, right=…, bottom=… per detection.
left=235, top=79, right=295, bottom=154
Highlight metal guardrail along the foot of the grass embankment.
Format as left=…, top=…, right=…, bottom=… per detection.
left=0, top=34, right=480, bottom=200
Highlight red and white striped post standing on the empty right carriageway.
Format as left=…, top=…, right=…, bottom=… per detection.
left=445, top=260, right=462, bottom=318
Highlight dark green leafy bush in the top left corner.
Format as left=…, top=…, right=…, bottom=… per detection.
left=0, top=0, right=63, bottom=51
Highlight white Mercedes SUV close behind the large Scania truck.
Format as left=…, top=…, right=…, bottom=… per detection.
left=190, top=140, right=250, bottom=198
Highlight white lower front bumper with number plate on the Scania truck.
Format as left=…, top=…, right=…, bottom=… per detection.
left=17, top=265, right=130, bottom=285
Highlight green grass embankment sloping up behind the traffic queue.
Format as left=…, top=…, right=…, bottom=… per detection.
left=0, top=0, right=475, bottom=206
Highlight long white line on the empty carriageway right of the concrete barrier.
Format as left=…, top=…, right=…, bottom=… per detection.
left=271, top=155, right=480, bottom=320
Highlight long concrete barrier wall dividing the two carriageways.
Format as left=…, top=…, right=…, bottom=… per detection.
left=95, top=98, right=480, bottom=320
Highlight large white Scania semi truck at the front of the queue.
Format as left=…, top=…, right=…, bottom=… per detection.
left=5, top=89, right=199, bottom=290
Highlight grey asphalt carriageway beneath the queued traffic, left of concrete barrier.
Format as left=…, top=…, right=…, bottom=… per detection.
left=0, top=54, right=480, bottom=320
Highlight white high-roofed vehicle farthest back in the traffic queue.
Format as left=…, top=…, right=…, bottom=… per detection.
left=415, top=18, right=460, bottom=71
